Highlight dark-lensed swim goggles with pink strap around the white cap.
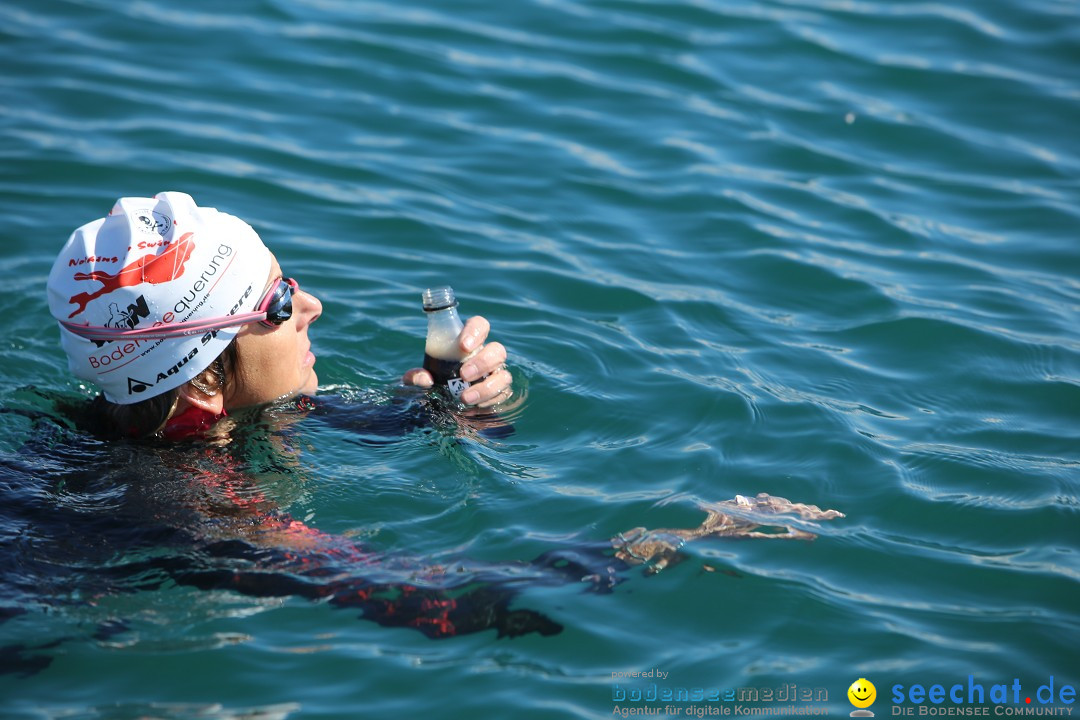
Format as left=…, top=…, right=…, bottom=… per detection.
left=60, top=277, right=300, bottom=342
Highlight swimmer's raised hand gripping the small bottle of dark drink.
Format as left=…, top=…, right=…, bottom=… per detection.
left=402, top=315, right=514, bottom=407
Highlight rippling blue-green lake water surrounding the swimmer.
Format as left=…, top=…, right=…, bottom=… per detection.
left=0, top=0, right=1080, bottom=718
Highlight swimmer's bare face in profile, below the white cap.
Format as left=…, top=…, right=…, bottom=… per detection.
left=226, top=253, right=323, bottom=409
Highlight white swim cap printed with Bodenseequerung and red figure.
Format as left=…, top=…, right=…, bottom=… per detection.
left=49, top=192, right=271, bottom=405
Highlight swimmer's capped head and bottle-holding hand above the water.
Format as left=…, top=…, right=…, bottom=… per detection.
left=49, top=192, right=512, bottom=439
